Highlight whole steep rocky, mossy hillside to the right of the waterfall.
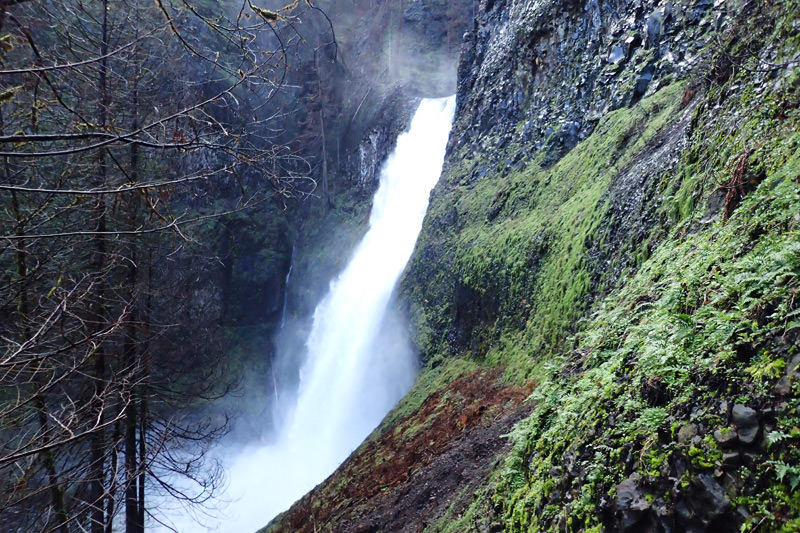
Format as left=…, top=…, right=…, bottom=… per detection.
left=265, top=0, right=800, bottom=532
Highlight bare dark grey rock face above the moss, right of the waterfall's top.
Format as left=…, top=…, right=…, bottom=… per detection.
left=454, top=0, right=716, bottom=163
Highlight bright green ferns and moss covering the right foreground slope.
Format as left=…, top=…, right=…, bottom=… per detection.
left=494, top=78, right=800, bottom=531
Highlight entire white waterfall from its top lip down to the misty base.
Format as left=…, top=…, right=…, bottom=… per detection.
left=159, top=97, right=455, bottom=533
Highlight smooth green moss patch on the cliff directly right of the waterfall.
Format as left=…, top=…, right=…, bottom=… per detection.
left=415, top=84, right=685, bottom=382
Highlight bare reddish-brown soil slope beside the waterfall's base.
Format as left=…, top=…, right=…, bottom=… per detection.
left=269, top=371, right=530, bottom=533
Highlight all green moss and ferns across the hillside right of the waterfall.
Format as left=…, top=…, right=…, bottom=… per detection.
left=404, top=6, right=800, bottom=532
